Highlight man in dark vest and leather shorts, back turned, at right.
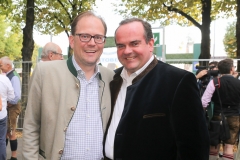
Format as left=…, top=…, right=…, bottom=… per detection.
left=202, top=59, right=240, bottom=160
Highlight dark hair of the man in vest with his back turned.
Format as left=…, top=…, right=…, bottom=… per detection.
left=218, top=58, right=233, bottom=74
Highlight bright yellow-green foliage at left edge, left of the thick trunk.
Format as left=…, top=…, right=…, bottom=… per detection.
left=0, top=16, right=22, bottom=61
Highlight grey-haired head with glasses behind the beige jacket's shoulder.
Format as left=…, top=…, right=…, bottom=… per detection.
left=41, top=42, right=63, bottom=61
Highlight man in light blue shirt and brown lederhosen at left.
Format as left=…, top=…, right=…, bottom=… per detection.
left=0, top=57, right=21, bottom=160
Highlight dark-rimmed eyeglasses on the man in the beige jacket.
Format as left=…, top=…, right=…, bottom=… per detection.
left=75, top=34, right=107, bottom=44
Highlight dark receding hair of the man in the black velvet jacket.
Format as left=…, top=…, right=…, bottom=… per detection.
left=115, top=18, right=153, bottom=43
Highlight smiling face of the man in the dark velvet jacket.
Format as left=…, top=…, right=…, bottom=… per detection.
left=115, top=22, right=154, bottom=75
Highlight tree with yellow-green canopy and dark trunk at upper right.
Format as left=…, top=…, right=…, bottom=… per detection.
left=116, top=0, right=236, bottom=66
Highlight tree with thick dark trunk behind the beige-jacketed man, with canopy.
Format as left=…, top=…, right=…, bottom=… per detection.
left=0, top=0, right=98, bottom=114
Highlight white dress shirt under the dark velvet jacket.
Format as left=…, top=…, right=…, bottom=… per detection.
left=105, top=55, right=154, bottom=159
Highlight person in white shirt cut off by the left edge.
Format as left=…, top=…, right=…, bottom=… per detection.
left=0, top=75, right=15, bottom=160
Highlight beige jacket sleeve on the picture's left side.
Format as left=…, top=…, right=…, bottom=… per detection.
left=22, top=65, right=42, bottom=160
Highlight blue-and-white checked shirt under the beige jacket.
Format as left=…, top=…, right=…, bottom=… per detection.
left=61, top=56, right=103, bottom=160
